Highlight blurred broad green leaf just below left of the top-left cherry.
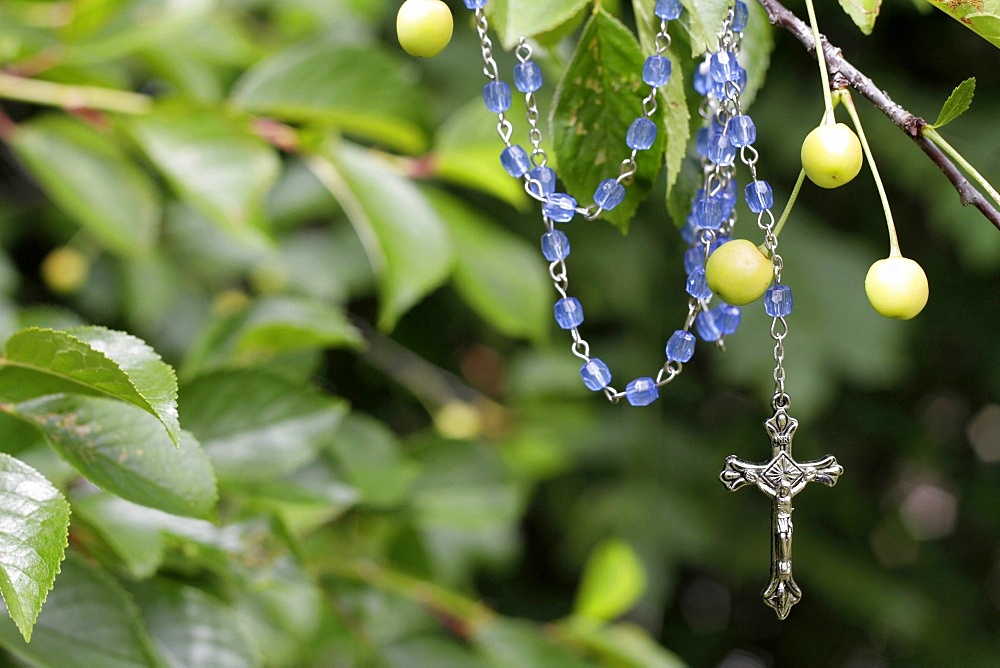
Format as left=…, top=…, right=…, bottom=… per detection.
left=232, top=41, right=427, bottom=153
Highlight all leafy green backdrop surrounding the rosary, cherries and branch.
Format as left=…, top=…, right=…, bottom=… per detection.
left=0, top=0, right=1000, bottom=667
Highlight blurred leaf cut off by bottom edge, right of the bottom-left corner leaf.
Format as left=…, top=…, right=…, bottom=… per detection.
left=134, top=580, right=260, bottom=668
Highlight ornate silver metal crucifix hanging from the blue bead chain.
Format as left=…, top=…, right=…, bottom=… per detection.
left=719, top=406, right=844, bottom=619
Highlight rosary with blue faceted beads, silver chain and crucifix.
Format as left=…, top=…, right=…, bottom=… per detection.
left=446, top=0, right=843, bottom=619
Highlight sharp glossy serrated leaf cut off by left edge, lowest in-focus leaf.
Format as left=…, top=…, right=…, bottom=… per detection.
left=0, top=453, right=69, bottom=642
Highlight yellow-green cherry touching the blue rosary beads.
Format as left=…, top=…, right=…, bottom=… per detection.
left=705, top=239, right=774, bottom=306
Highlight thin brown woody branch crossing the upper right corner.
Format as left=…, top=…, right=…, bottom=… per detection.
left=758, top=0, right=1000, bottom=230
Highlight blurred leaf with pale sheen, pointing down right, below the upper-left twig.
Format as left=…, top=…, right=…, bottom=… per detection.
left=130, top=104, right=279, bottom=243
